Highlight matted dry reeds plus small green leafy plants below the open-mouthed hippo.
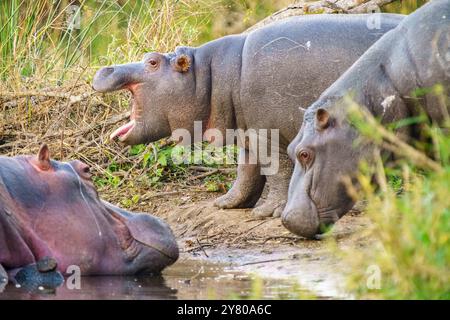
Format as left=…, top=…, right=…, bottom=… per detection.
left=0, top=83, right=239, bottom=210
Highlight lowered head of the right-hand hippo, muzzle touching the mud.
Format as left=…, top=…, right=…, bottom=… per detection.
left=282, top=101, right=365, bottom=238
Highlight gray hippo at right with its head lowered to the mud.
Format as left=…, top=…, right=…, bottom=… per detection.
left=282, top=0, right=450, bottom=238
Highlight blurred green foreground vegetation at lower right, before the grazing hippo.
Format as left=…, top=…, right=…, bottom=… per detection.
left=347, top=90, right=450, bottom=299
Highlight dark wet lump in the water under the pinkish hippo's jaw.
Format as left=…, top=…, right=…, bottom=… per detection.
left=14, top=257, right=64, bottom=291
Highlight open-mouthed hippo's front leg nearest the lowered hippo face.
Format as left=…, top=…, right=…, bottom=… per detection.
left=252, top=152, right=293, bottom=218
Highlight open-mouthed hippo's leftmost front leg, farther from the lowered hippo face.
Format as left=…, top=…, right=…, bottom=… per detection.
left=214, top=148, right=266, bottom=209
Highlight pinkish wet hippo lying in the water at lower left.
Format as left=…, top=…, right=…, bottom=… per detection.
left=0, top=145, right=178, bottom=275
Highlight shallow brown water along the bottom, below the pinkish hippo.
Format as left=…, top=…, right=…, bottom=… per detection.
left=0, top=260, right=312, bottom=300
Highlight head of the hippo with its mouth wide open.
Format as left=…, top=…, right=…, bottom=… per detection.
left=93, top=47, right=208, bottom=144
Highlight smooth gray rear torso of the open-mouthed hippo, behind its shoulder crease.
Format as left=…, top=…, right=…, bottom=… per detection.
left=240, top=14, right=404, bottom=143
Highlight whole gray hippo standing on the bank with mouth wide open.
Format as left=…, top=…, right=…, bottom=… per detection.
left=93, top=14, right=403, bottom=217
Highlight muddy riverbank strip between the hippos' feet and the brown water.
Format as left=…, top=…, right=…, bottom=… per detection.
left=150, top=189, right=371, bottom=298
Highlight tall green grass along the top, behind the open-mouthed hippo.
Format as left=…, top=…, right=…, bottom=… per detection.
left=0, top=0, right=287, bottom=85
